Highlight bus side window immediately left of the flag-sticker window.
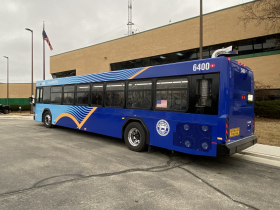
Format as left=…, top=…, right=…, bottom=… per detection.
left=127, top=81, right=152, bottom=109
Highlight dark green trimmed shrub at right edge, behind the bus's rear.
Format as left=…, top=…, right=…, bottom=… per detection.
left=255, top=99, right=280, bottom=119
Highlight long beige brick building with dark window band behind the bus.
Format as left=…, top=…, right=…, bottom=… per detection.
left=0, top=0, right=280, bottom=103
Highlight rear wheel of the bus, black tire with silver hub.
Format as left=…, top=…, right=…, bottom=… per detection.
left=124, top=122, right=147, bottom=152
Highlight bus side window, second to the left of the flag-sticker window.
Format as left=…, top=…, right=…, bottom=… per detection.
left=105, top=82, right=125, bottom=108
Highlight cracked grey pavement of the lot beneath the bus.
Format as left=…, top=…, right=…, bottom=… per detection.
left=0, top=117, right=280, bottom=209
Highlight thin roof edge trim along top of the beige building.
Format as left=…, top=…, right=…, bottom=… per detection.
left=50, top=0, right=255, bottom=57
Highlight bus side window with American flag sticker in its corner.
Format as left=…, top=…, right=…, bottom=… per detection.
left=155, top=78, right=188, bottom=111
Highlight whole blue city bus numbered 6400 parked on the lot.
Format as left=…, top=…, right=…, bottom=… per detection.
left=34, top=57, right=257, bottom=156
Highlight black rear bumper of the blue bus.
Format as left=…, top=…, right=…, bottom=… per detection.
left=217, top=135, right=258, bottom=156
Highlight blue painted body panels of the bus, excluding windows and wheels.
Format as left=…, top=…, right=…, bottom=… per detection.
left=35, top=57, right=254, bottom=156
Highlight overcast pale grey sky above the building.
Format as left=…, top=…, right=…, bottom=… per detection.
left=0, top=0, right=252, bottom=83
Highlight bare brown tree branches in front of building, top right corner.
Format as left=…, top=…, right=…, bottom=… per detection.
left=239, top=0, right=280, bottom=32
